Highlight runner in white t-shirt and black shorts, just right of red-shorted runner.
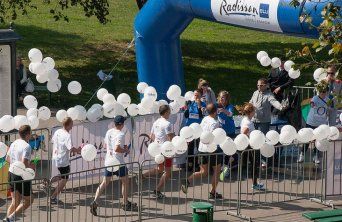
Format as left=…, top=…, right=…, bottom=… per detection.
left=181, top=104, right=223, bottom=199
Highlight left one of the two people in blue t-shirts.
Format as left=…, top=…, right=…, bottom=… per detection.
left=184, top=89, right=205, bottom=171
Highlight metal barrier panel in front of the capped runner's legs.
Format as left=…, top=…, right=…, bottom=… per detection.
left=50, top=162, right=140, bottom=222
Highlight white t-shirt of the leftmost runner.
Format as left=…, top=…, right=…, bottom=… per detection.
left=7, top=139, right=31, bottom=166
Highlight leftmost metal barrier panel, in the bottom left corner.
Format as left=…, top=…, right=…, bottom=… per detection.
left=0, top=179, right=49, bottom=221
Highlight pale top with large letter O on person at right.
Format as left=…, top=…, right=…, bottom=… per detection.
left=307, top=96, right=328, bottom=126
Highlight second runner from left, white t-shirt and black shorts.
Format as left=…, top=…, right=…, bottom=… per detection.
left=50, top=117, right=81, bottom=204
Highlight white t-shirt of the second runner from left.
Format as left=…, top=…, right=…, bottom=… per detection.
left=51, top=129, right=72, bottom=167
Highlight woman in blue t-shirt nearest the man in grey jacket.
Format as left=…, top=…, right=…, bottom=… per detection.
left=216, top=90, right=235, bottom=181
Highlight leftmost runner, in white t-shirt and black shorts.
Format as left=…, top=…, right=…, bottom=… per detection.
left=6, top=125, right=35, bottom=222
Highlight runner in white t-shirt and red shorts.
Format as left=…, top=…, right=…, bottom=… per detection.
left=142, top=105, right=175, bottom=199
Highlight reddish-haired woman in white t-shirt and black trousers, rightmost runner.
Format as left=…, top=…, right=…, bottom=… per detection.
left=236, top=103, right=264, bottom=190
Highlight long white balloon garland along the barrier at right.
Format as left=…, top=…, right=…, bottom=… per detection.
left=148, top=123, right=339, bottom=164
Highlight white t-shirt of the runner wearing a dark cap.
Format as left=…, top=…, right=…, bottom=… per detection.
left=104, top=128, right=125, bottom=164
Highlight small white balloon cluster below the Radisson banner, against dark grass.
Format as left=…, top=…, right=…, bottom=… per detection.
left=257, top=51, right=300, bottom=79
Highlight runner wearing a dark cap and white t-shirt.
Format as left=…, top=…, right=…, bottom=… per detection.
left=90, top=115, right=137, bottom=216
